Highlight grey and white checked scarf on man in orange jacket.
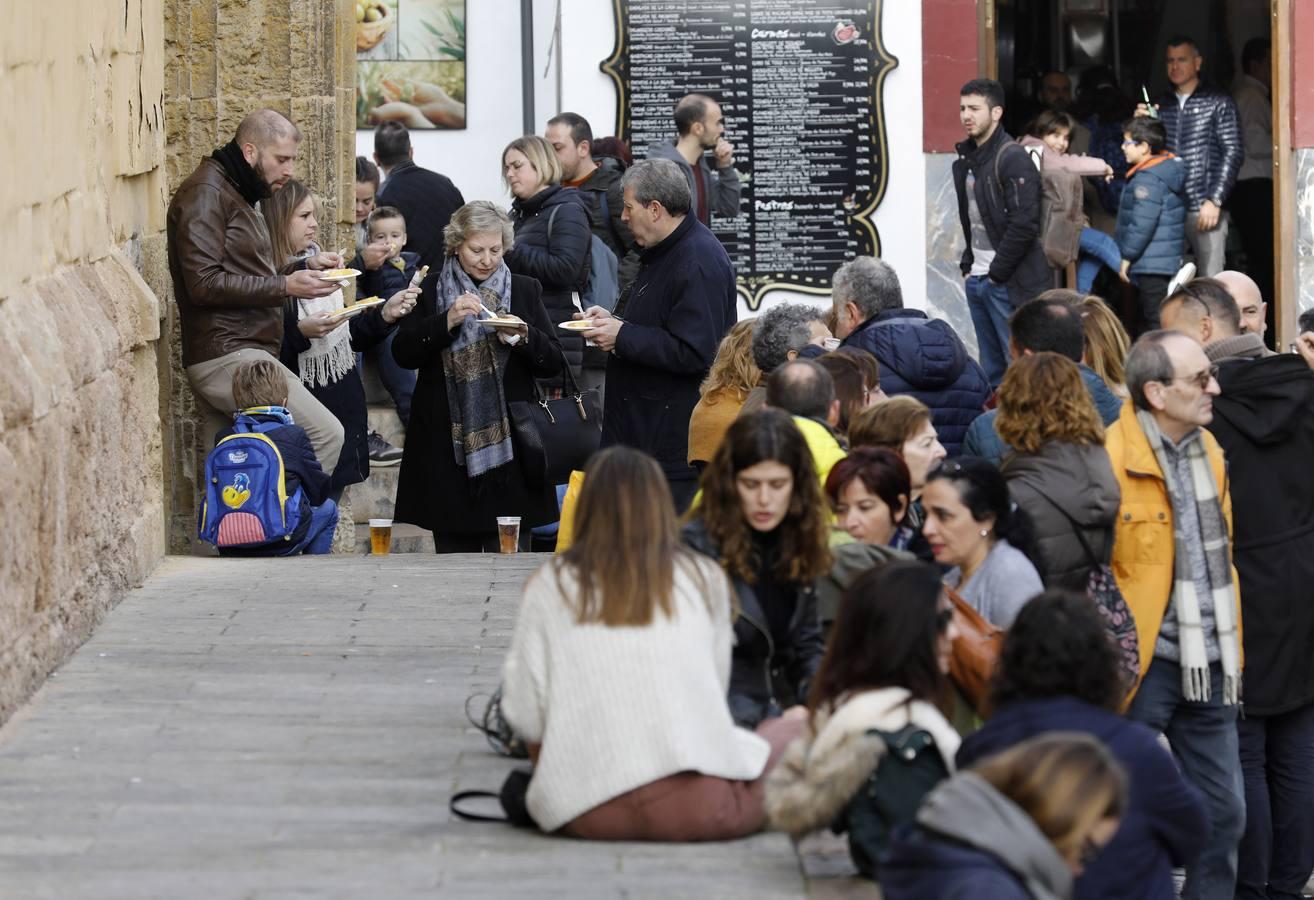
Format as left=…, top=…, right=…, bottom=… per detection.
left=1137, top=410, right=1240, bottom=706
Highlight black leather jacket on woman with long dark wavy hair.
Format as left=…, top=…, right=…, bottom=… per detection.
left=683, top=519, right=825, bottom=728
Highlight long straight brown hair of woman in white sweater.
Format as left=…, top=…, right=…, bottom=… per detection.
left=555, top=447, right=711, bottom=627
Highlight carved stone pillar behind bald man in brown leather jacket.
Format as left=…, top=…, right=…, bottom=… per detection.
left=145, top=0, right=356, bottom=552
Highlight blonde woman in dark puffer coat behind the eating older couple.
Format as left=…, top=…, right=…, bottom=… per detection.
left=502, top=134, right=596, bottom=388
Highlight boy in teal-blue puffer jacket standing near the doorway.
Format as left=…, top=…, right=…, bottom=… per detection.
left=1113, top=117, right=1187, bottom=331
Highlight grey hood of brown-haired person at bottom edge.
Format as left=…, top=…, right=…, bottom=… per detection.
left=917, top=771, right=1072, bottom=900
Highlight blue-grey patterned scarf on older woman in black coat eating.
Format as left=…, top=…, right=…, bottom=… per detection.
left=438, top=256, right=514, bottom=478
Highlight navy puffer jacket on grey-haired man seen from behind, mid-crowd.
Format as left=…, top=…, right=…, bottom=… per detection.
left=844, top=309, right=991, bottom=456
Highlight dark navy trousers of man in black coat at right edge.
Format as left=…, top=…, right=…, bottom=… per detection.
left=1236, top=703, right=1314, bottom=900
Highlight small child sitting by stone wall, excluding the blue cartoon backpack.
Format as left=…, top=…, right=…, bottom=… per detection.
left=214, top=360, right=338, bottom=556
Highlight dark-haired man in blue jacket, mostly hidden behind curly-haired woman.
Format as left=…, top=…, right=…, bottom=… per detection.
left=963, top=294, right=1122, bottom=465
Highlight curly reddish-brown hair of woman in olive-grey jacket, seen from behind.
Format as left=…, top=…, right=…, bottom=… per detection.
left=995, top=352, right=1104, bottom=453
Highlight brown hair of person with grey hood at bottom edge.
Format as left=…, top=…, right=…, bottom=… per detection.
left=972, top=732, right=1127, bottom=859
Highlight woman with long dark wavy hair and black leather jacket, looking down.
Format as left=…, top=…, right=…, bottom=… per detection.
left=683, top=409, right=830, bottom=728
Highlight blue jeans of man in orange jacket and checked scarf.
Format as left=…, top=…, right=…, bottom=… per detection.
left=1127, top=658, right=1246, bottom=900
